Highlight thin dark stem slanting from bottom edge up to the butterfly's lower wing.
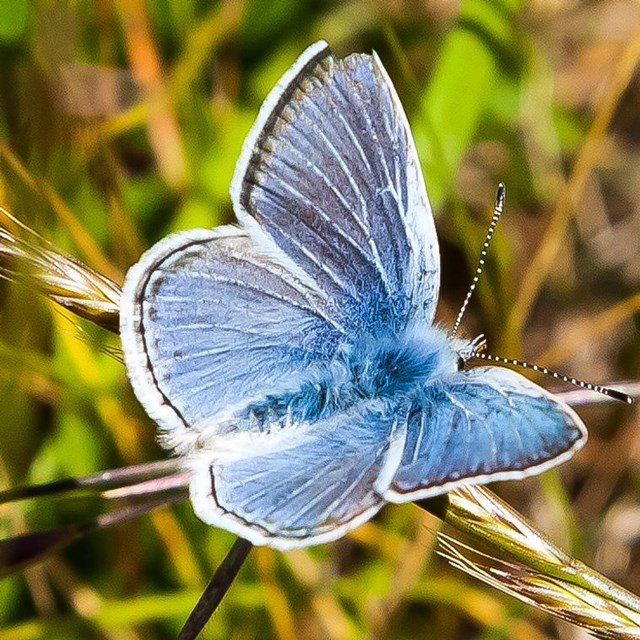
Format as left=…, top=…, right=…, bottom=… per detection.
left=178, top=538, right=253, bottom=640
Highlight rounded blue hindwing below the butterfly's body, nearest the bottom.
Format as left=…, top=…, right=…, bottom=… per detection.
left=190, top=403, right=404, bottom=549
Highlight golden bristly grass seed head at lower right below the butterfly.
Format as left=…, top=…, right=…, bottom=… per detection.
left=419, top=486, right=640, bottom=638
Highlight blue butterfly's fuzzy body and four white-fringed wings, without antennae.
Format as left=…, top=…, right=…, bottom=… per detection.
left=121, top=42, right=587, bottom=549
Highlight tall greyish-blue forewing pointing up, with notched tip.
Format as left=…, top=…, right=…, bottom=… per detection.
left=231, top=42, right=439, bottom=335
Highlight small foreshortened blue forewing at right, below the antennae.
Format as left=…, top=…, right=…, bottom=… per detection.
left=384, top=367, right=587, bottom=502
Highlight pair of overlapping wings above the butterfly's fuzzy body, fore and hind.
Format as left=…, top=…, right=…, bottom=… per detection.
left=121, top=42, right=439, bottom=442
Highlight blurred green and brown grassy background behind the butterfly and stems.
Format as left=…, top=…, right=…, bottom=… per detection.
left=0, top=0, right=640, bottom=640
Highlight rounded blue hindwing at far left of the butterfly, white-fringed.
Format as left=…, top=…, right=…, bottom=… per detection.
left=121, top=227, right=342, bottom=444
